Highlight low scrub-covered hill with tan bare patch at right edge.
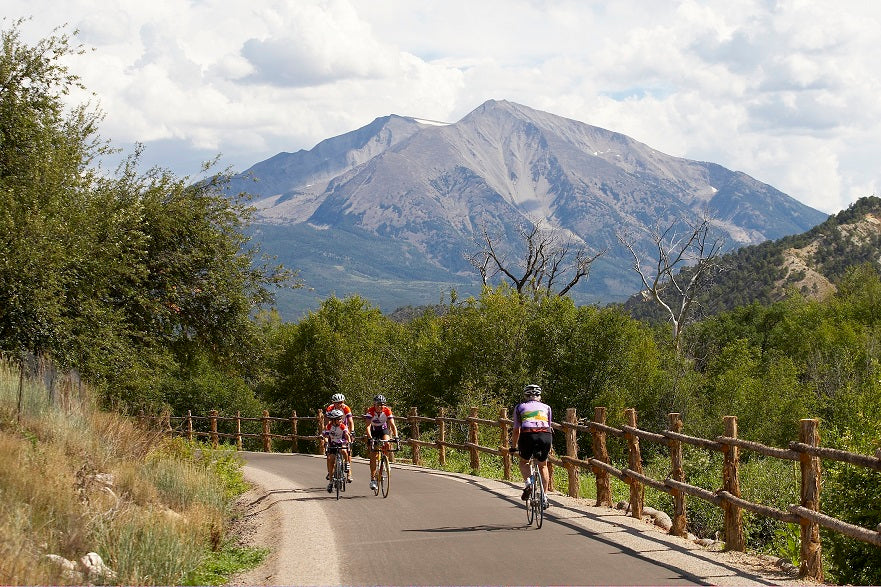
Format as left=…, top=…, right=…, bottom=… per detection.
left=624, top=196, right=881, bottom=321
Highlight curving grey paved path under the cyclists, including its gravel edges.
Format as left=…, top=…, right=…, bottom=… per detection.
left=235, top=453, right=804, bottom=585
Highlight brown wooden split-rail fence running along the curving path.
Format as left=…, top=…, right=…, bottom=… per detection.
left=160, top=407, right=881, bottom=581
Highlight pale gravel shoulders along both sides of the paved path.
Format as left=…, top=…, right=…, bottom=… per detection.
left=229, top=457, right=818, bottom=586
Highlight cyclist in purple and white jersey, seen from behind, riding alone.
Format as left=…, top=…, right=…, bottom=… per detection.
left=511, top=384, right=553, bottom=508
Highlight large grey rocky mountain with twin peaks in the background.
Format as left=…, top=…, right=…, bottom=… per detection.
left=230, top=100, right=827, bottom=317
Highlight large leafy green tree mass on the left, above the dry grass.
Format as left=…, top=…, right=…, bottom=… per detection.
left=0, top=21, right=290, bottom=408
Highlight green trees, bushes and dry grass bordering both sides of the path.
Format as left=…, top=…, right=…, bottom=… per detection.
left=0, top=16, right=881, bottom=584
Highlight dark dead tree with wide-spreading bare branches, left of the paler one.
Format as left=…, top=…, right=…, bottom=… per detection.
left=466, top=221, right=606, bottom=296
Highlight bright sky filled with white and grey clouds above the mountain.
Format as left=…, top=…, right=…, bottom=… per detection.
left=8, top=0, right=881, bottom=213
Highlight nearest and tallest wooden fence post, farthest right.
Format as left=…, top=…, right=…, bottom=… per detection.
left=798, top=418, right=823, bottom=582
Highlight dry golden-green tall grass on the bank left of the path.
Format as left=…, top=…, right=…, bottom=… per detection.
left=0, top=359, right=260, bottom=585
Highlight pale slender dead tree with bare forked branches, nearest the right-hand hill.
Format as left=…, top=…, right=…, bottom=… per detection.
left=617, top=214, right=724, bottom=352
